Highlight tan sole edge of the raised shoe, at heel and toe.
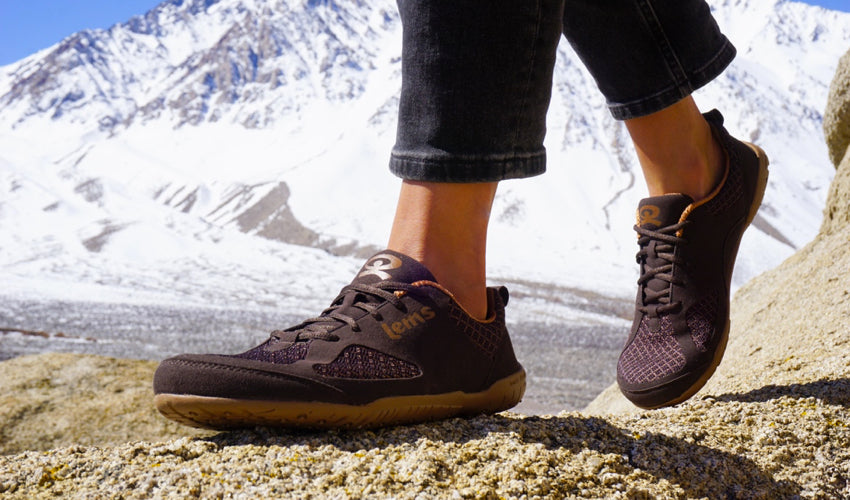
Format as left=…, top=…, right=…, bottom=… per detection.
left=623, top=141, right=770, bottom=410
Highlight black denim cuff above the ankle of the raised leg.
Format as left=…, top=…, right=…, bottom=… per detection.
left=607, top=40, right=736, bottom=120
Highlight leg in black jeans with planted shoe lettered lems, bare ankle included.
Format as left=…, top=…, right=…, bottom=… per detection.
left=154, top=0, right=561, bottom=428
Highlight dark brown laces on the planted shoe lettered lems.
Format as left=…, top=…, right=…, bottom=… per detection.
left=271, top=281, right=413, bottom=343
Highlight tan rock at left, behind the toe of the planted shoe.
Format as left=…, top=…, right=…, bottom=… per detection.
left=0, top=354, right=209, bottom=454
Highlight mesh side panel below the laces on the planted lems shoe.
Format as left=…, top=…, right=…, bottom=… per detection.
left=313, top=345, right=422, bottom=380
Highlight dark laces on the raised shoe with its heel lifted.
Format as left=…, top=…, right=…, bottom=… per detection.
left=634, top=221, right=689, bottom=317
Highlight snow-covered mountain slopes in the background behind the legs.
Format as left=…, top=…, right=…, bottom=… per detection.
left=0, top=0, right=850, bottom=323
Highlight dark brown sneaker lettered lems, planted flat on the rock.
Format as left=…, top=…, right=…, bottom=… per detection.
left=154, top=251, right=525, bottom=429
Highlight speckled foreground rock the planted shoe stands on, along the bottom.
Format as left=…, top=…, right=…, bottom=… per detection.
left=0, top=386, right=850, bottom=499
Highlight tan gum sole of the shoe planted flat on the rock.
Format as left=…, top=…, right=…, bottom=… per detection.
left=154, top=369, right=525, bottom=430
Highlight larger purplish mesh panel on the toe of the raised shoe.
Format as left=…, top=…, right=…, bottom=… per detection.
left=617, top=316, right=685, bottom=384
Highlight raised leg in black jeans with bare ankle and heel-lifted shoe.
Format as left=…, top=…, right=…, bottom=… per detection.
left=564, top=0, right=767, bottom=408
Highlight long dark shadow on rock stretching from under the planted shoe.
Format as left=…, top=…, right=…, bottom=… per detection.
left=199, top=415, right=802, bottom=498
